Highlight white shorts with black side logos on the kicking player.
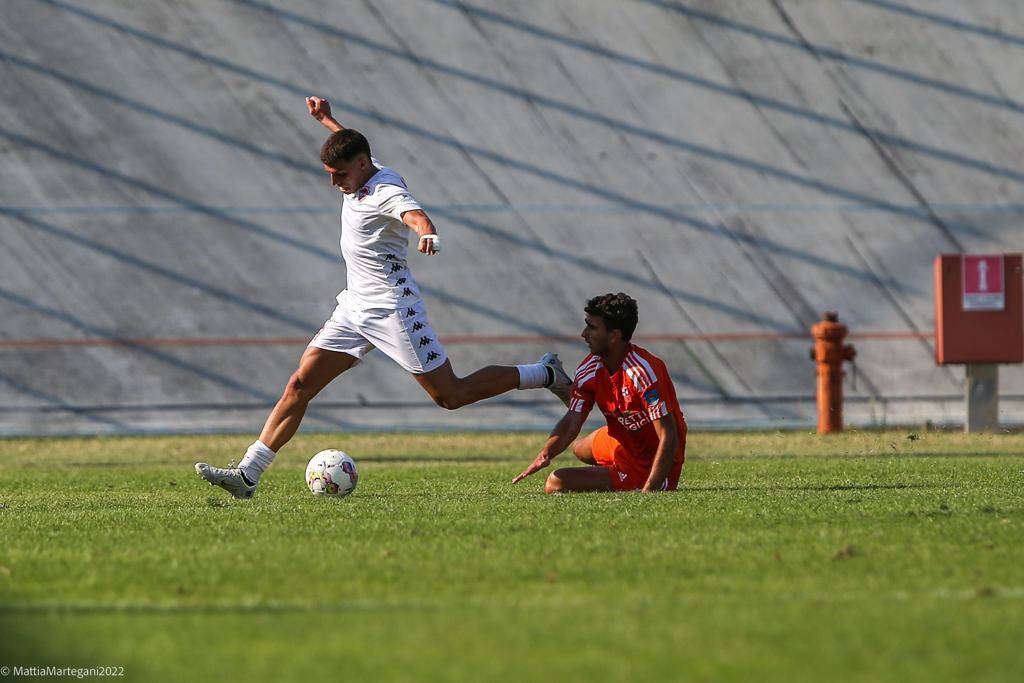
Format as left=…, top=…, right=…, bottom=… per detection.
left=309, top=297, right=447, bottom=375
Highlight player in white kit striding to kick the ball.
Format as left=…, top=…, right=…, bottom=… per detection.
left=196, top=97, right=572, bottom=499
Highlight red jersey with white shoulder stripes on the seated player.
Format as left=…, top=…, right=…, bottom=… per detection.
left=569, top=344, right=686, bottom=471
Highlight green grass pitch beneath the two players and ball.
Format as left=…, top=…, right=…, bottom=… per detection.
left=0, top=432, right=1024, bottom=682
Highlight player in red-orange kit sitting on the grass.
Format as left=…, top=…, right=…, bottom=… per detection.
left=512, top=293, right=686, bottom=494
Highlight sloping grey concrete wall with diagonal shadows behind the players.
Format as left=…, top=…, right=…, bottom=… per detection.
left=0, top=0, right=1024, bottom=434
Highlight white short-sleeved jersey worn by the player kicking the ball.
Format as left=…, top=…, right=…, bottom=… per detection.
left=338, top=159, right=422, bottom=309
